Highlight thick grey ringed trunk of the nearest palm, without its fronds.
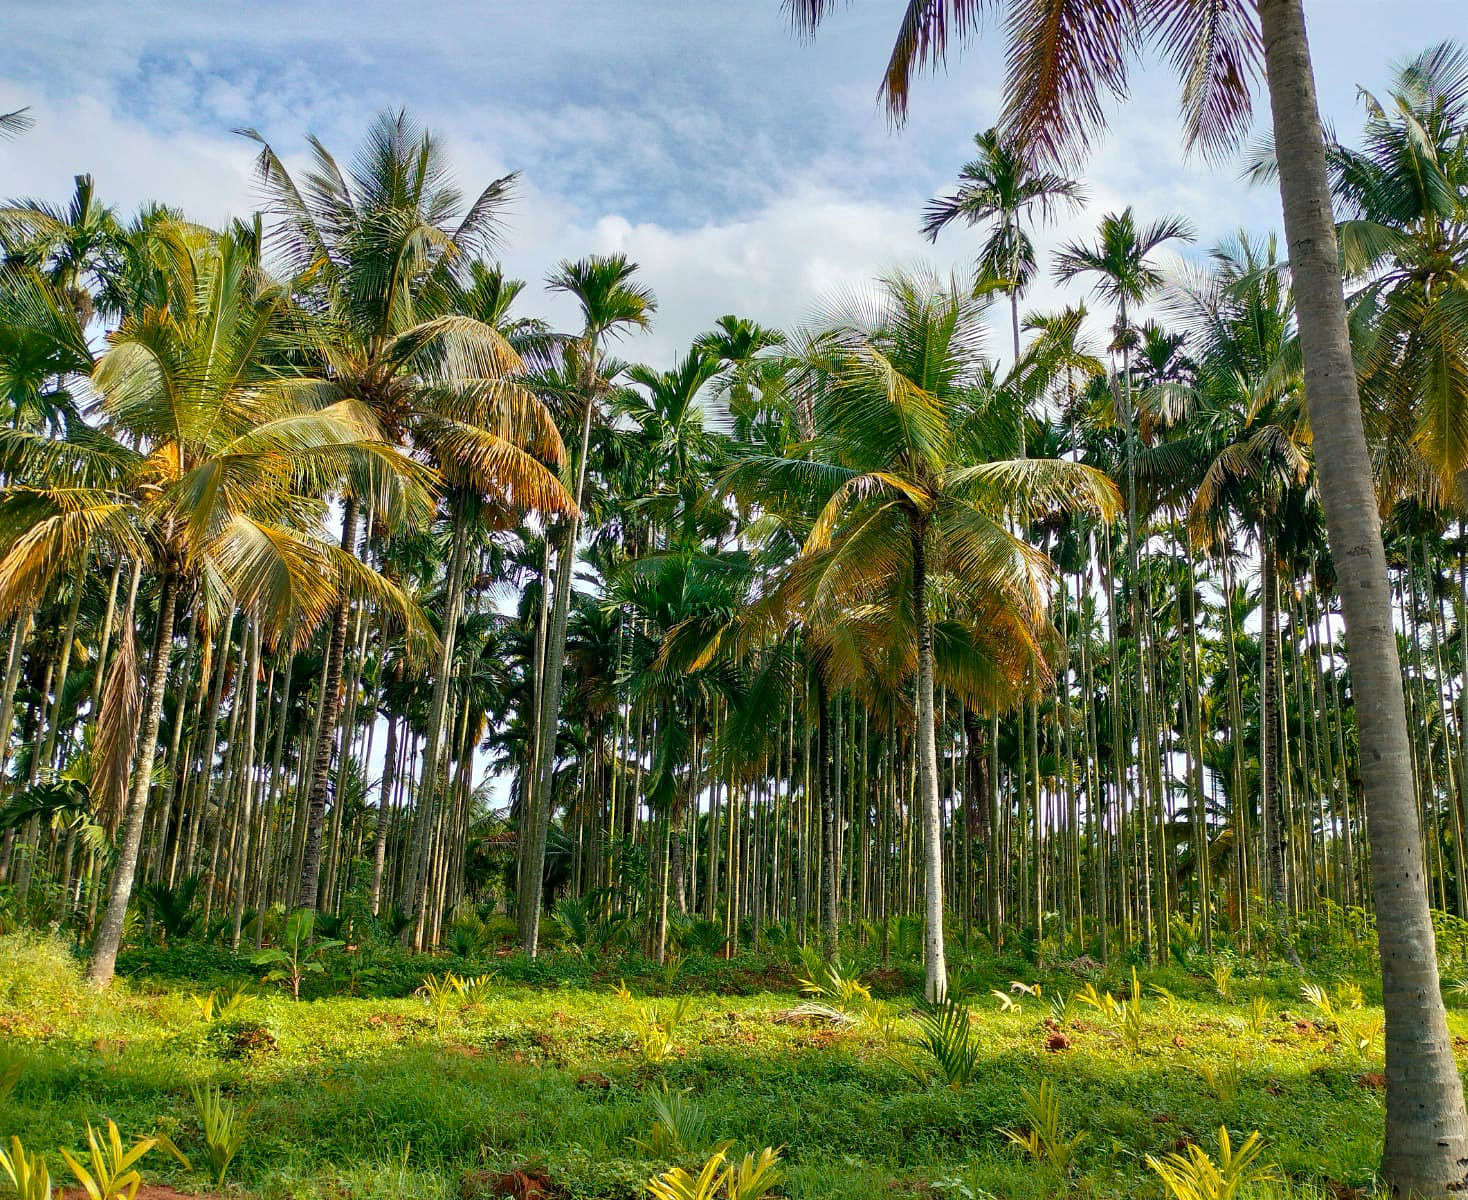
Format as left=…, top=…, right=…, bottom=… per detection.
left=1258, top=0, right=1468, bottom=1196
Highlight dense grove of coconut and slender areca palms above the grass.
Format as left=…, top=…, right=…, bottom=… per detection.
left=0, top=3, right=1468, bottom=1188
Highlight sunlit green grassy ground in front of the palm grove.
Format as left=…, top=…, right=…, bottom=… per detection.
left=0, top=936, right=1444, bottom=1200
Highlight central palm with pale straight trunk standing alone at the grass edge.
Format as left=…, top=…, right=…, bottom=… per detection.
left=728, top=268, right=1116, bottom=999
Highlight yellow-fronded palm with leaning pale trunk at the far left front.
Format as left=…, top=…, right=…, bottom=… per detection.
left=0, top=228, right=432, bottom=984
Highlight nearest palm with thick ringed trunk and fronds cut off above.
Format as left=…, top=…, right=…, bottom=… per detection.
left=787, top=0, right=1468, bottom=1196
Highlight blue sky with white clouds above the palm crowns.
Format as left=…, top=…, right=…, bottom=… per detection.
left=0, top=0, right=1458, bottom=363
